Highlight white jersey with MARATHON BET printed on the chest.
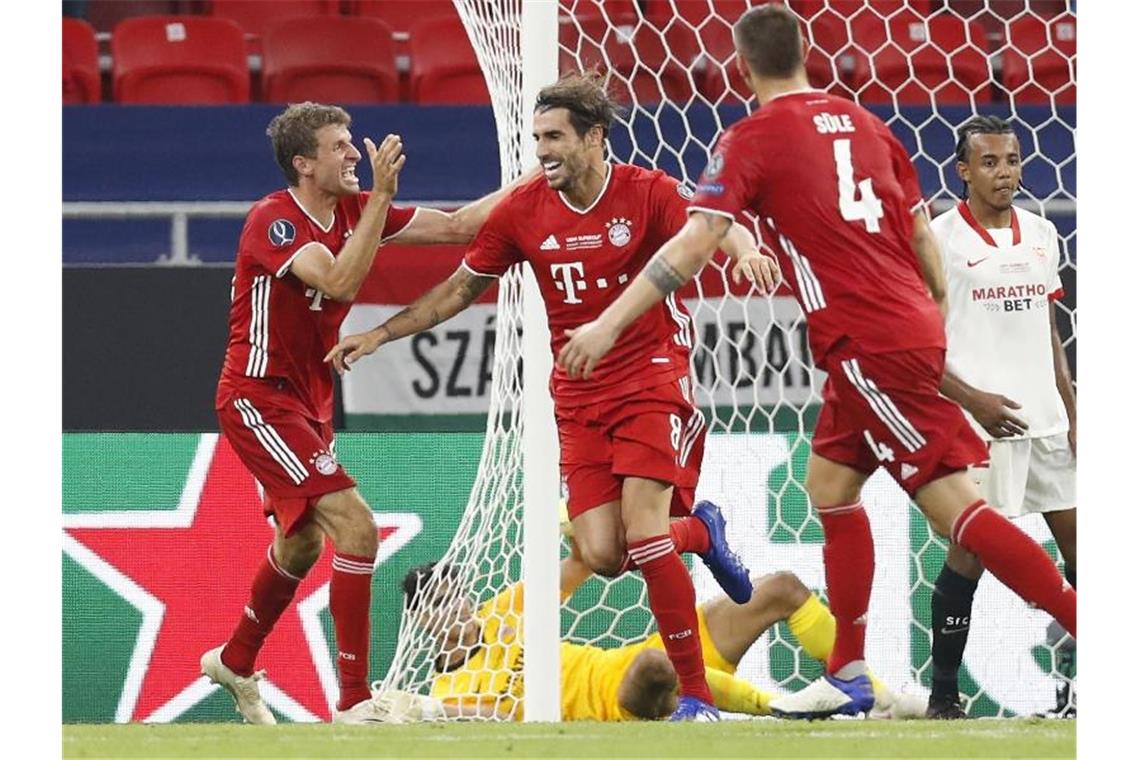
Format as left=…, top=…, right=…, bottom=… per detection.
left=930, top=202, right=1068, bottom=440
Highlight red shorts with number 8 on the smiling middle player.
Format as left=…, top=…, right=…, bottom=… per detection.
left=554, top=377, right=705, bottom=520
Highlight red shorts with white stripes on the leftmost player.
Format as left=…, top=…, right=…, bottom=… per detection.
left=218, top=397, right=356, bottom=536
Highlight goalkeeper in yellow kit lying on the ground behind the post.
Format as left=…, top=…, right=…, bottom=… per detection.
left=375, top=539, right=925, bottom=722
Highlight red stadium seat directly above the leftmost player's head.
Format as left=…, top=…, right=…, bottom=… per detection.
left=262, top=16, right=400, bottom=103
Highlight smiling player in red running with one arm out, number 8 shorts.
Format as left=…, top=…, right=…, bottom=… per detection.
left=327, top=74, right=777, bottom=720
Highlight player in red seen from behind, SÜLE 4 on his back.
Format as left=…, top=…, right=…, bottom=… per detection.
left=560, top=5, right=1076, bottom=717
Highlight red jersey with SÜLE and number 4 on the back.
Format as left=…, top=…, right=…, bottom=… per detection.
left=690, top=90, right=946, bottom=367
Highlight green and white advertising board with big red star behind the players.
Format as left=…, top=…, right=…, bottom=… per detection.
left=63, top=433, right=1057, bottom=722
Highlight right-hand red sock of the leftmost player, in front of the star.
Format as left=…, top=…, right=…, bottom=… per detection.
left=328, top=551, right=375, bottom=711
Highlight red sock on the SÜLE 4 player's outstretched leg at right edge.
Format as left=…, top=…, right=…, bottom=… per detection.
left=950, top=499, right=1076, bottom=638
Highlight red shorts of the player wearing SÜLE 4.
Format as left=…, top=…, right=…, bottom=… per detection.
left=812, top=342, right=990, bottom=496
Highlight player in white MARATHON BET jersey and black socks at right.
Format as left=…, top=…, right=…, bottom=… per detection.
left=927, top=116, right=1076, bottom=718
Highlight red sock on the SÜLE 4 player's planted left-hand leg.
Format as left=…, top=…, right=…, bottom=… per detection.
left=816, top=501, right=874, bottom=675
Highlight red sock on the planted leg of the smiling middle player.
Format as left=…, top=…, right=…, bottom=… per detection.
left=629, top=532, right=713, bottom=704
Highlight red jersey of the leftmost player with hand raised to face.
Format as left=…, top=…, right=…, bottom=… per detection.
left=214, top=190, right=416, bottom=422
